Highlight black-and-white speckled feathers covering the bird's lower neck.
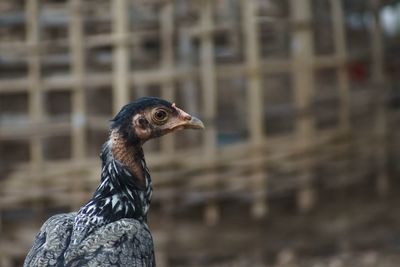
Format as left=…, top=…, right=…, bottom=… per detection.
left=71, top=151, right=152, bottom=246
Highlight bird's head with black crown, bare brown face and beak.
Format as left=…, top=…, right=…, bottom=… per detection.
left=111, top=97, right=204, bottom=145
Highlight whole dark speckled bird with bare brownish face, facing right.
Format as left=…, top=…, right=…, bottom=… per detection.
left=24, top=97, right=204, bottom=267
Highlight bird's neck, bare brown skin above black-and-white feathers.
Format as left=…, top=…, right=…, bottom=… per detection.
left=93, top=131, right=152, bottom=219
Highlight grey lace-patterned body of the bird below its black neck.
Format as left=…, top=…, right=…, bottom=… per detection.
left=24, top=213, right=155, bottom=267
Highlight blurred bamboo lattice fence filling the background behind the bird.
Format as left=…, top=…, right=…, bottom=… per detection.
left=0, top=0, right=397, bottom=267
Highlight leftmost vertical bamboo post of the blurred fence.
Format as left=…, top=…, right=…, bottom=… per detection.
left=25, top=0, right=44, bottom=170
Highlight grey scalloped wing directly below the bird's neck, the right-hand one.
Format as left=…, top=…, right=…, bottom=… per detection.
left=64, top=219, right=155, bottom=267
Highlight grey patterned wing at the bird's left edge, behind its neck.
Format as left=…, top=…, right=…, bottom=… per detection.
left=24, top=213, right=76, bottom=267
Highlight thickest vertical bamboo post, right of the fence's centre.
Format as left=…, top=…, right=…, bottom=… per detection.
left=290, top=0, right=315, bottom=212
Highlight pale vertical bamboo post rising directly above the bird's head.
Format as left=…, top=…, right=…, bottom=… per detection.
left=111, top=0, right=130, bottom=113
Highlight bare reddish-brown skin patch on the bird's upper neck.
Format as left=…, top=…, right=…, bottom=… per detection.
left=110, top=130, right=145, bottom=185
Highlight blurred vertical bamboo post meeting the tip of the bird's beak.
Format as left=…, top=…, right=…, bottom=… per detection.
left=200, top=0, right=219, bottom=225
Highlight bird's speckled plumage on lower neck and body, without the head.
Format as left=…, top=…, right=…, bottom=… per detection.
left=24, top=146, right=155, bottom=266
